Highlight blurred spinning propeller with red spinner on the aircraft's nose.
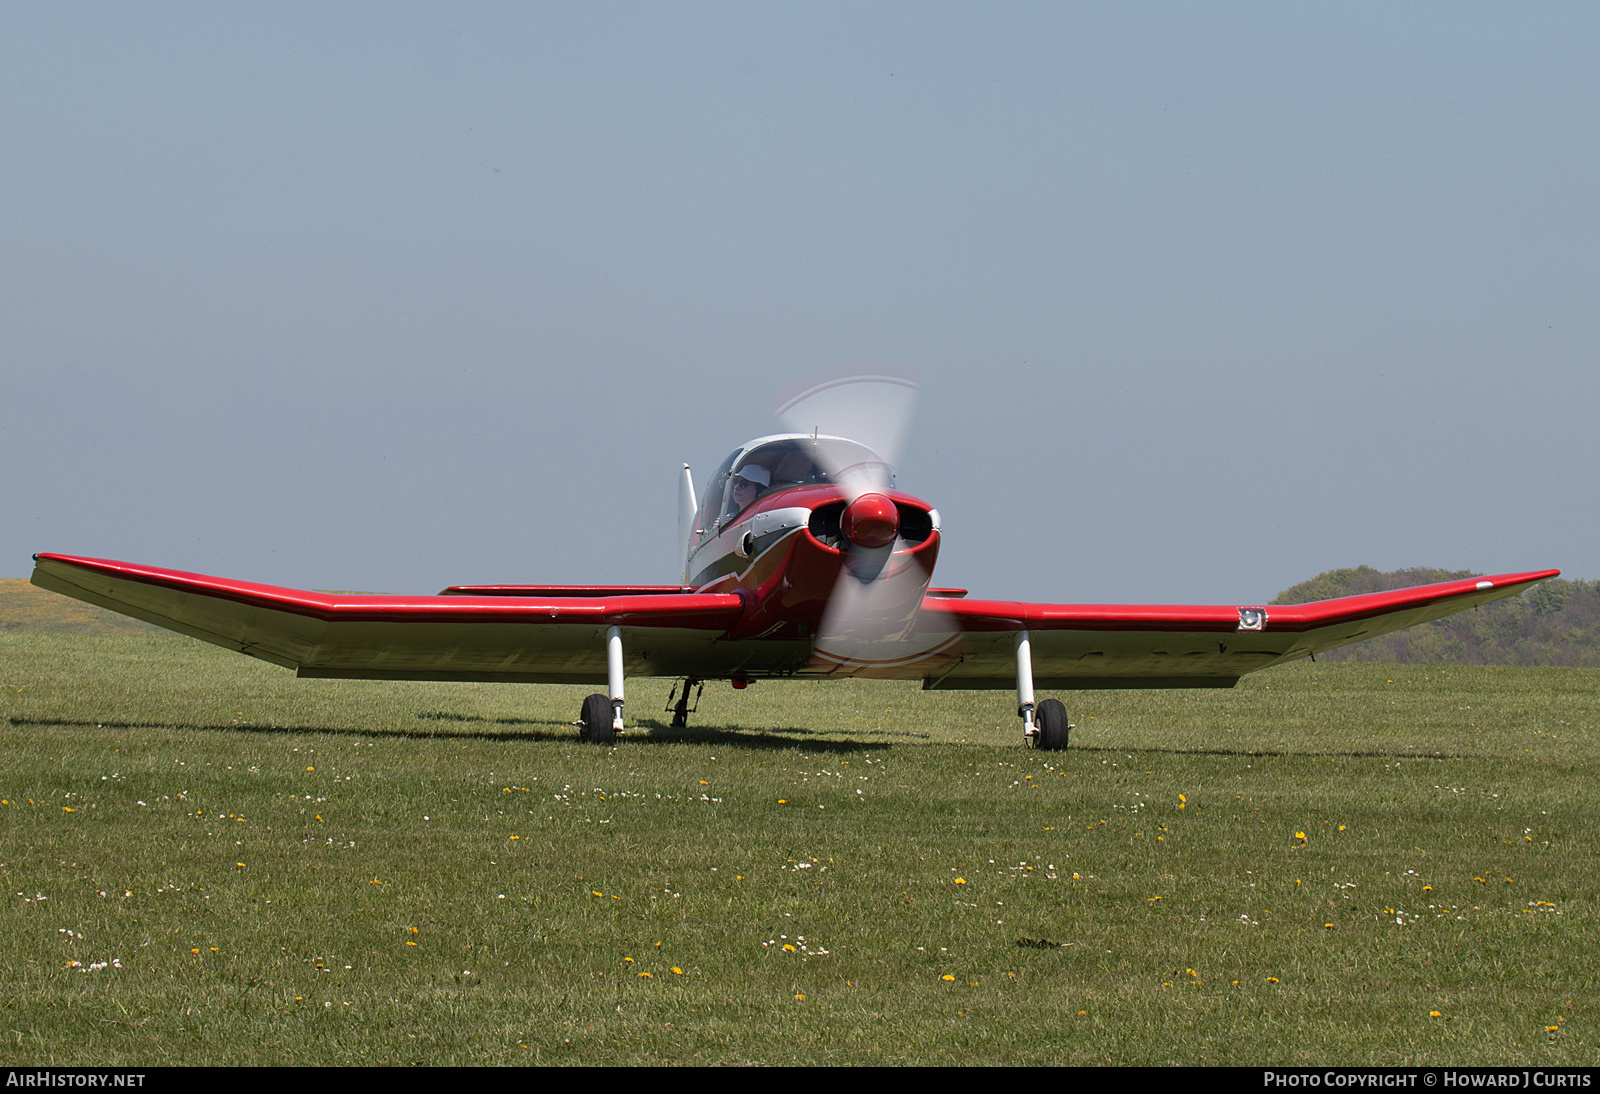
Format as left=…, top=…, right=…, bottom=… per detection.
left=776, top=371, right=926, bottom=667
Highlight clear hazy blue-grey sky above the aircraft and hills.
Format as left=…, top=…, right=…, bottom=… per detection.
left=0, top=2, right=1600, bottom=603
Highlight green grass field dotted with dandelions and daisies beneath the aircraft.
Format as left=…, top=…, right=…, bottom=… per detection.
left=0, top=633, right=1600, bottom=1065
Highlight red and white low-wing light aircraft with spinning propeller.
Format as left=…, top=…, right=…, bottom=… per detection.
left=32, top=373, right=1560, bottom=750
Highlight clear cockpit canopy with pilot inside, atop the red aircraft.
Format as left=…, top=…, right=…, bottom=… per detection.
left=694, top=433, right=894, bottom=531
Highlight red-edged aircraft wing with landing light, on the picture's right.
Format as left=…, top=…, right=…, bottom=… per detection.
left=917, top=569, right=1562, bottom=691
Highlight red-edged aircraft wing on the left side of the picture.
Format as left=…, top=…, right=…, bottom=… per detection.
left=34, top=555, right=744, bottom=685
